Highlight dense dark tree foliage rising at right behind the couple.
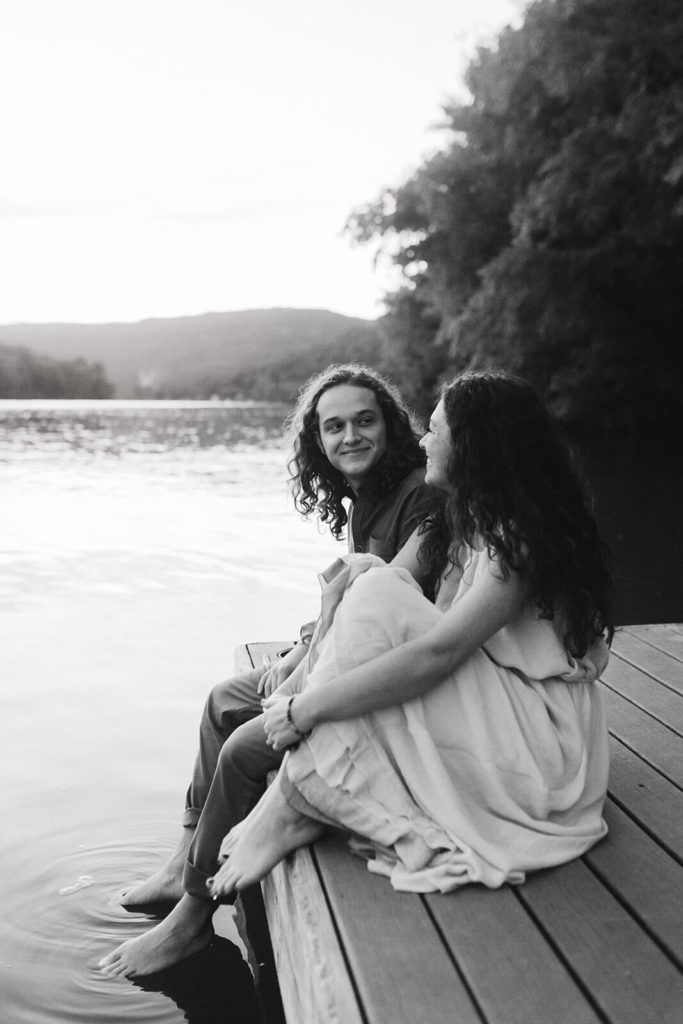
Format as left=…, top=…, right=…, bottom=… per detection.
left=348, top=0, right=683, bottom=428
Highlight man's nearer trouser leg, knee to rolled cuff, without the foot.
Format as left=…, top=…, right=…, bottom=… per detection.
left=183, top=718, right=284, bottom=901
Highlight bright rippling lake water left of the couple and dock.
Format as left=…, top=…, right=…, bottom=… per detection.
left=0, top=401, right=340, bottom=1024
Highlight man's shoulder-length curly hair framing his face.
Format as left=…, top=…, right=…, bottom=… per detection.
left=287, top=362, right=425, bottom=540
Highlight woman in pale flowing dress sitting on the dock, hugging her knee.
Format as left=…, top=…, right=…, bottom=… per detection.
left=210, top=373, right=613, bottom=897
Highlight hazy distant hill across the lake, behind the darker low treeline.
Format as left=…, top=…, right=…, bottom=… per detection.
left=0, top=309, right=380, bottom=400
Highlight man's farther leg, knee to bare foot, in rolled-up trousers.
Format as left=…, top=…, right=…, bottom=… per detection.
left=119, top=669, right=262, bottom=907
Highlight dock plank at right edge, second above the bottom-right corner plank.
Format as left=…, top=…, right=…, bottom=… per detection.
left=608, top=736, right=683, bottom=863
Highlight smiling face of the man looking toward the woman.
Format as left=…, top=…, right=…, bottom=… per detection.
left=317, top=384, right=387, bottom=490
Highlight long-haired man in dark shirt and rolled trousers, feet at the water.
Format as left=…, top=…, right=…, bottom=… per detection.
left=101, top=364, right=431, bottom=974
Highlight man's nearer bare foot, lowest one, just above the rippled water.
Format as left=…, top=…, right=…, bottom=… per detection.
left=97, top=893, right=215, bottom=978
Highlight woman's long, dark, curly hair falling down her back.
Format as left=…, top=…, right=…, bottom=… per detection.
left=421, top=371, right=614, bottom=656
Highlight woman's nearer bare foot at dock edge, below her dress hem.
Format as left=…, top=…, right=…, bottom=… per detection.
left=207, top=785, right=325, bottom=899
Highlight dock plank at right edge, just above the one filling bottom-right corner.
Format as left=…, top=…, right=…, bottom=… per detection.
left=584, top=801, right=683, bottom=966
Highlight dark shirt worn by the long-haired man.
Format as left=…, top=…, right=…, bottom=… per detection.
left=348, top=468, right=430, bottom=562
